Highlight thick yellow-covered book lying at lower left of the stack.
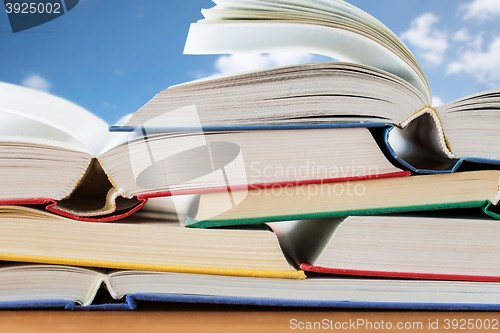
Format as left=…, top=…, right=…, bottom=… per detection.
left=0, top=206, right=305, bottom=279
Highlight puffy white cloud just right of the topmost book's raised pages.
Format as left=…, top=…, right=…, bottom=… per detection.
left=401, top=13, right=448, bottom=65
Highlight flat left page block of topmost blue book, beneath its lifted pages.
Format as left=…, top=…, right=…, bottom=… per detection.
left=124, top=62, right=426, bottom=129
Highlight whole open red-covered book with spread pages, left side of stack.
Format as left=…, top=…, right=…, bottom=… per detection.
left=0, top=83, right=409, bottom=221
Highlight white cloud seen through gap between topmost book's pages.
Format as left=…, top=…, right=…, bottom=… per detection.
left=214, top=53, right=314, bottom=75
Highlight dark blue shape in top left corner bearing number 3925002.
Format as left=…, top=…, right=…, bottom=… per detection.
left=4, top=0, right=79, bottom=33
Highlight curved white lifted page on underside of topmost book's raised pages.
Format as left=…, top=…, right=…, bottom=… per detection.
left=184, top=22, right=432, bottom=104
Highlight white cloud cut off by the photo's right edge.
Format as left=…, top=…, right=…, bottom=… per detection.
left=447, top=36, right=500, bottom=83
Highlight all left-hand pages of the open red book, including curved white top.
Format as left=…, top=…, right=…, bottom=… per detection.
left=0, top=83, right=114, bottom=205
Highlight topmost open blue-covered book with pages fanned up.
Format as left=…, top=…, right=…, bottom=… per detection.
left=114, top=0, right=500, bottom=172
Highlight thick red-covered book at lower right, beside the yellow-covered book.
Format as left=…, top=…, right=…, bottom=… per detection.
left=272, top=214, right=500, bottom=283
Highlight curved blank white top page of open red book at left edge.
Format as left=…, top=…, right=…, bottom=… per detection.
left=0, top=82, right=108, bottom=156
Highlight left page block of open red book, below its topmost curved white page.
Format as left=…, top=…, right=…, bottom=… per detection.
left=0, top=109, right=93, bottom=203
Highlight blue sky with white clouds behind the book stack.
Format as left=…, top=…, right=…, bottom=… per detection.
left=0, top=0, right=500, bottom=123
